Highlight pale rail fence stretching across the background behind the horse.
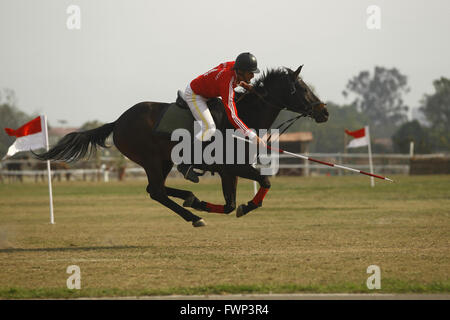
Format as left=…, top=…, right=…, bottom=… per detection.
left=0, top=153, right=448, bottom=182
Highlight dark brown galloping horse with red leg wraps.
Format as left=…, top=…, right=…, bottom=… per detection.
left=31, top=65, right=329, bottom=227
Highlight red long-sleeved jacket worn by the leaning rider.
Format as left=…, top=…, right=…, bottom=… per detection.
left=191, top=61, right=256, bottom=138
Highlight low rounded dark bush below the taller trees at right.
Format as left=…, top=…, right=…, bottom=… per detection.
left=392, top=120, right=432, bottom=153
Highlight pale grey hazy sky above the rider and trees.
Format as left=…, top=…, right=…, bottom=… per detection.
left=0, top=0, right=450, bottom=126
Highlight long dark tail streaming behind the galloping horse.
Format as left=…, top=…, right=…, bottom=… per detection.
left=33, top=122, right=115, bottom=162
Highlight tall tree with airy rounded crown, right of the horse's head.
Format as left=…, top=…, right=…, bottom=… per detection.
left=343, top=67, right=409, bottom=138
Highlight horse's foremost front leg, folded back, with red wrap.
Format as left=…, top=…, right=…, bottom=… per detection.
left=229, top=165, right=270, bottom=218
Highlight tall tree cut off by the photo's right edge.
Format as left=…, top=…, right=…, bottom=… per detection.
left=420, top=77, right=450, bottom=151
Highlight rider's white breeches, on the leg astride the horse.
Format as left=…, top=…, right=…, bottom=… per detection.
left=184, top=85, right=216, bottom=141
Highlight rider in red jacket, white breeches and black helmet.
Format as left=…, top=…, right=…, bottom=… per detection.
left=177, top=52, right=264, bottom=182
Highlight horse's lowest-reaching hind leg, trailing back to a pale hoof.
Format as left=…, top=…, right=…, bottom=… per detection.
left=144, top=162, right=205, bottom=227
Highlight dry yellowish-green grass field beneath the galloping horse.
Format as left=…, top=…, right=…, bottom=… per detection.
left=0, top=175, right=450, bottom=298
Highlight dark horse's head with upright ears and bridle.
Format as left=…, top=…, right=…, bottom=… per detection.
left=284, top=65, right=329, bottom=122
